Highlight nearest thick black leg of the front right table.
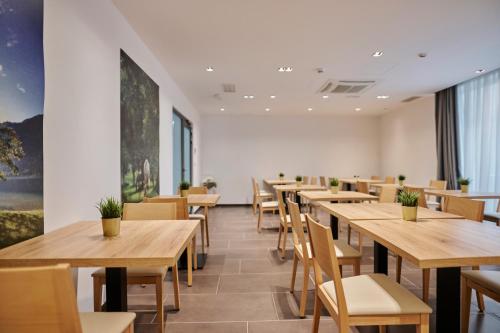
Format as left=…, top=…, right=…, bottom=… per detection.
left=436, top=267, right=460, bottom=333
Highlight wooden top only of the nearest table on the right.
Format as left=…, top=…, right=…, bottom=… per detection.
left=350, top=219, right=500, bottom=268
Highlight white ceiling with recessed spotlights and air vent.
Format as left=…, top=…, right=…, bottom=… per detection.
left=114, top=0, right=500, bottom=115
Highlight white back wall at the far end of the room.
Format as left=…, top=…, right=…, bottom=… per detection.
left=201, top=115, right=380, bottom=204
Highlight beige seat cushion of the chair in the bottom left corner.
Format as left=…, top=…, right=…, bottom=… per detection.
left=80, top=312, right=135, bottom=333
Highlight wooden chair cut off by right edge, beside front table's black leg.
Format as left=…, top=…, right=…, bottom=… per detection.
left=460, top=270, right=500, bottom=333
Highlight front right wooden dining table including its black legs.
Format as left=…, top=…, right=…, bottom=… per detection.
left=349, top=218, right=500, bottom=333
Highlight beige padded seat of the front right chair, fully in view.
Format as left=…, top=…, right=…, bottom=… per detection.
left=321, top=274, right=432, bottom=316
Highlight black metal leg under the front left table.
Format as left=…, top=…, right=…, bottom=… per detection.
left=106, top=267, right=127, bottom=312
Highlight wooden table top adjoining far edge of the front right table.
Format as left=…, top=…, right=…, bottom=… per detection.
left=320, top=202, right=462, bottom=221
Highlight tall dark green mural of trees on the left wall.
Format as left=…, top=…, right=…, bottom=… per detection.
left=120, top=50, right=160, bottom=202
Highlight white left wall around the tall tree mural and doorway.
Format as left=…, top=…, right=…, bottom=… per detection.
left=44, top=0, right=200, bottom=309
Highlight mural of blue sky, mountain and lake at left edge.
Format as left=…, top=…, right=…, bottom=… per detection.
left=0, top=0, right=44, bottom=248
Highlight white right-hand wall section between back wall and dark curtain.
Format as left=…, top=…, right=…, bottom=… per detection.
left=380, top=96, right=437, bottom=184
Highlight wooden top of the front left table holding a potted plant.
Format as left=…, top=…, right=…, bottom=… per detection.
left=0, top=220, right=200, bottom=267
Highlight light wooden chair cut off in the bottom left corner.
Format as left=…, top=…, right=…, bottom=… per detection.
left=0, top=264, right=135, bottom=333
